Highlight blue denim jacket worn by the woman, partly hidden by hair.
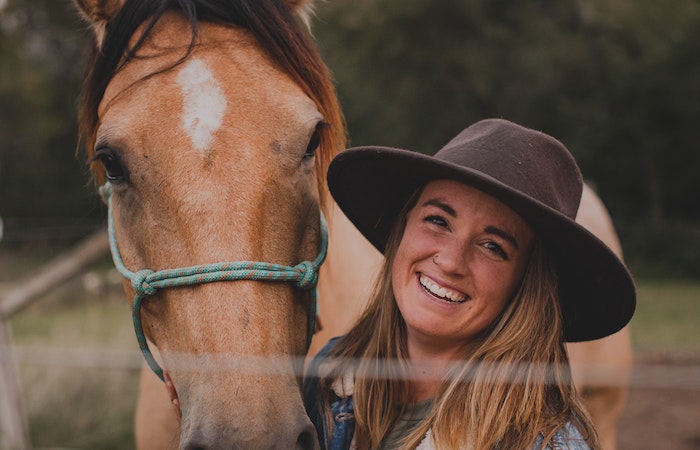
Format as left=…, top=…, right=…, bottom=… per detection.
left=304, top=338, right=590, bottom=450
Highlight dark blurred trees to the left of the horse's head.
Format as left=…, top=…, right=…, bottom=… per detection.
left=0, top=0, right=99, bottom=218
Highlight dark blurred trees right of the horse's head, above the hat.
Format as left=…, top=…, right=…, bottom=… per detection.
left=315, top=0, right=700, bottom=225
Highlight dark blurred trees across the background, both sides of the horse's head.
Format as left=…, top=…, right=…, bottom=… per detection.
left=0, top=0, right=700, bottom=271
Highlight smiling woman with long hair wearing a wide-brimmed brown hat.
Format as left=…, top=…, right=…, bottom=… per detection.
left=304, top=119, right=636, bottom=450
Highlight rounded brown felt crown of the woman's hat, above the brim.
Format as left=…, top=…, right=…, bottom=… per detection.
left=434, top=119, right=583, bottom=220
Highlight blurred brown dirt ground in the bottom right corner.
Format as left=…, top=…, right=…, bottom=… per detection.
left=618, top=356, right=700, bottom=450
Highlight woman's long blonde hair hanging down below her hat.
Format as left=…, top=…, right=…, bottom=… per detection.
left=319, top=185, right=599, bottom=450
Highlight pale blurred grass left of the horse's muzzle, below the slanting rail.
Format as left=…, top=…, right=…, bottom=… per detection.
left=5, top=276, right=140, bottom=450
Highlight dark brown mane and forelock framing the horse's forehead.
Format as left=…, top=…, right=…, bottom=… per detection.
left=79, top=0, right=346, bottom=205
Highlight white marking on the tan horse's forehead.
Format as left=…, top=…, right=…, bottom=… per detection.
left=177, top=59, right=226, bottom=152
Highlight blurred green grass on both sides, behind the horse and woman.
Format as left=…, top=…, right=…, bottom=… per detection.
left=1, top=262, right=700, bottom=449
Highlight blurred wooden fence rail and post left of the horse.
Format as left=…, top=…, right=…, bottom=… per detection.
left=0, top=229, right=109, bottom=450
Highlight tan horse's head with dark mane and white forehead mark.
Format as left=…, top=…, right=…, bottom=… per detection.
left=75, top=0, right=345, bottom=449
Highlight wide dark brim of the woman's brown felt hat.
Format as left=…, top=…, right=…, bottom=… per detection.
left=327, top=147, right=636, bottom=342
